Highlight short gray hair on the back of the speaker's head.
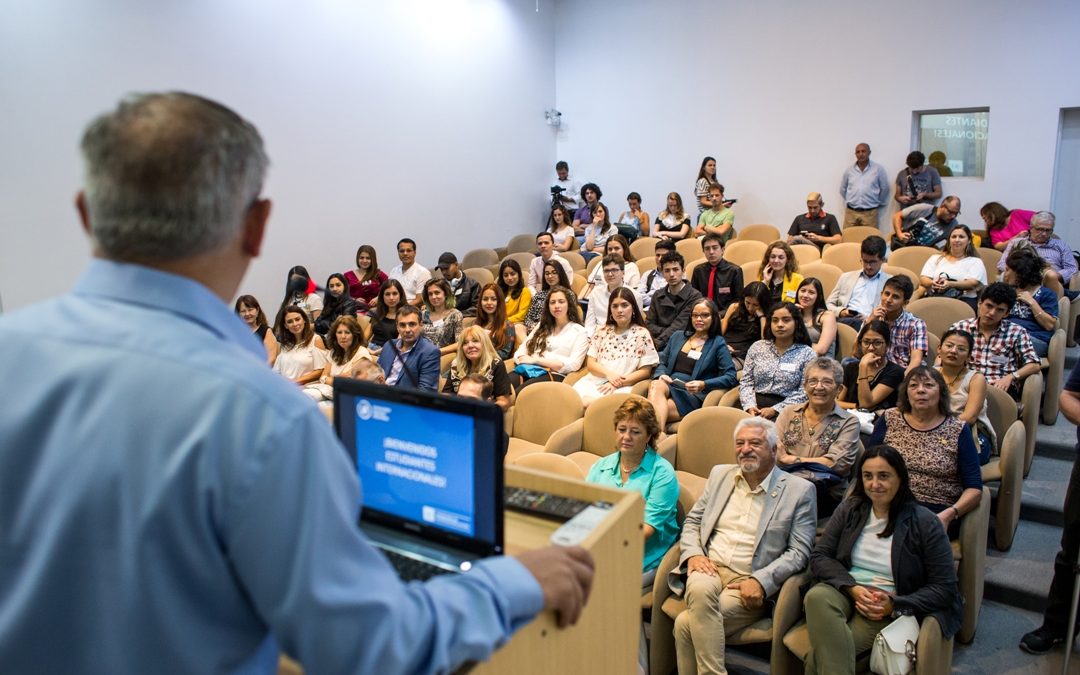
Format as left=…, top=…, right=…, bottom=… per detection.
left=82, top=92, right=270, bottom=262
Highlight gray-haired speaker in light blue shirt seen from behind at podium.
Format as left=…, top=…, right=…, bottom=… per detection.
left=0, top=94, right=592, bottom=674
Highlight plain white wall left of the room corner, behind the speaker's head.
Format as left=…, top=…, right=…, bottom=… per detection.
left=0, top=0, right=555, bottom=310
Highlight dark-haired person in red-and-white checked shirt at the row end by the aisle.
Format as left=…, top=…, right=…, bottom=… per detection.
left=951, top=281, right=1041, bottom=399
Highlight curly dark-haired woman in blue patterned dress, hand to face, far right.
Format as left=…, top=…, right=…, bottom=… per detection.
left=1002, top=247, right=1058, bottom=357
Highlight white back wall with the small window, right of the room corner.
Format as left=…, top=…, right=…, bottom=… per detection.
left=555, top=0, right=1080, bottom=246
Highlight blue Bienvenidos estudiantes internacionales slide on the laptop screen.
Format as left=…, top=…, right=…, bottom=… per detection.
left=355, top=399, right=475, bottom=537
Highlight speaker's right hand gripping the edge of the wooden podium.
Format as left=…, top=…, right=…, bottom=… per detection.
left=517, top=546, right=595, bottom=629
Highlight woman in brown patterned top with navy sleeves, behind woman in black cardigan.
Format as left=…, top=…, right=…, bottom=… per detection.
left=869, top=365, right=983, bottom=538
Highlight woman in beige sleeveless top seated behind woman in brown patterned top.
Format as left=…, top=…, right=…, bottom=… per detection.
left=935, top=329, right=998, bottom=464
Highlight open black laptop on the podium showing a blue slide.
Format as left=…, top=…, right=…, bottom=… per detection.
left=334, top=377, right=503, bottom=580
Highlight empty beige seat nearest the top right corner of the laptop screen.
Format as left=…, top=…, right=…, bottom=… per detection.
left=505, top=382, right=583, bottom=464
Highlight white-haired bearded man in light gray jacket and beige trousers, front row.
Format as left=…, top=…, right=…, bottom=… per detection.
left=667, top=417, right=818, bottom=675
